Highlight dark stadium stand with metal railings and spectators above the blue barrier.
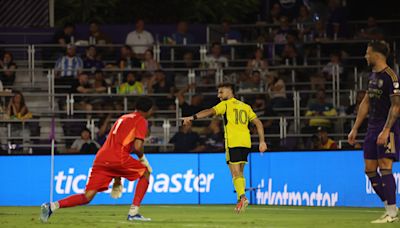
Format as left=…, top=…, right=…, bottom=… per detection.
left=0, top=4, right=400, bottom=154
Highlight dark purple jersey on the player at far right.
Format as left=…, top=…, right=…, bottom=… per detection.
left=368, top=67, right=400, bottom=127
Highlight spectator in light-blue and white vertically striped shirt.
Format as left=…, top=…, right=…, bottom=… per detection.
left=55, top=44, right=83, bottom=78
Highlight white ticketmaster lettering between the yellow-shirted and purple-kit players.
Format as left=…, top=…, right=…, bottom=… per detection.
left=256, top=178, right=339, bottom=207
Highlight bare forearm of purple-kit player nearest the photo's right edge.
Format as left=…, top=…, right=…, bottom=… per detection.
left=376, top=95, right=400, bottom=145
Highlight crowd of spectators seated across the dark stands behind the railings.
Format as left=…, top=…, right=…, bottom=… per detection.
left=0, top=0, right=392, bottom=153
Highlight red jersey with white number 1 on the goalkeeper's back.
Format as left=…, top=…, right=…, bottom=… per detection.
left=94, top=112, right=147, bottom=165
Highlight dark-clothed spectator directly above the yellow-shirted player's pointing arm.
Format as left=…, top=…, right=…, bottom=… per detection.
left=176, top=84, right=204, bottom=116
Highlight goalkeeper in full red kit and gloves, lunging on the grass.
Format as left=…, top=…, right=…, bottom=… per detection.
left=40, top=97, right=153, bottom=222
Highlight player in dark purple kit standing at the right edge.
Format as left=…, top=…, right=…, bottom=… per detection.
left=348, top=41, right=400, bottom=223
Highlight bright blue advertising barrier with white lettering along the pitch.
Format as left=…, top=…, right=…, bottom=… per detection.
left=0, top=151, right=400, bottom=207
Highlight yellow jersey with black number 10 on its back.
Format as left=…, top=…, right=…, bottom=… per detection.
left=213, top=98, right=257, bottom=149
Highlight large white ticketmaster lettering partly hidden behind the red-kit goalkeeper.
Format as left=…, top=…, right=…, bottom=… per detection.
left=54, top=168, right=214, bottom=194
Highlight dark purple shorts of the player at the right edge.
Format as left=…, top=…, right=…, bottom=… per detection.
left=363, top=125, right=400, bottom=161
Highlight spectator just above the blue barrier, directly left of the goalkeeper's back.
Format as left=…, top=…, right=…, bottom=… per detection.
left=67, top=128, right=100, bottom=154
